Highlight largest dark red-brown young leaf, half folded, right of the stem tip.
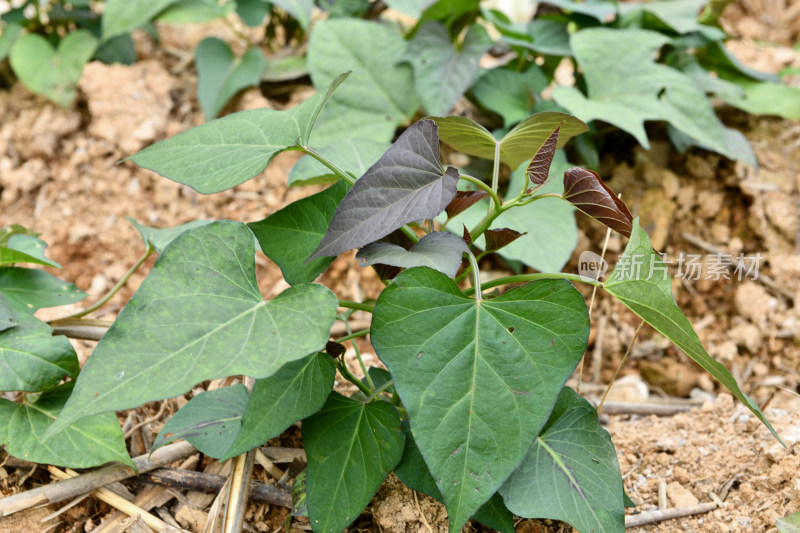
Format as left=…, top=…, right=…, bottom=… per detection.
left=564, top=167, right=633, bottom=237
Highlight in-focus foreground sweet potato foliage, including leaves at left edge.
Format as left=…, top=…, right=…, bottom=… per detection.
left=0, top=74, right=772, bottom=533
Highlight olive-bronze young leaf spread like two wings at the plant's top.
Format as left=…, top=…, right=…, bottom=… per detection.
left=431, top=112, right=589, bottom=170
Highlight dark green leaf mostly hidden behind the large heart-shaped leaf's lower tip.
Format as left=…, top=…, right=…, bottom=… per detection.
left=396, top=420, right=514, bottom=533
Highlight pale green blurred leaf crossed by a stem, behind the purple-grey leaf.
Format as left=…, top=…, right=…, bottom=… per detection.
left=289, top=137, right=392, bottom=187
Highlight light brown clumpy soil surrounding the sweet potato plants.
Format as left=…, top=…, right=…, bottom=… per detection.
left=0, top=4, right=800, bottom=533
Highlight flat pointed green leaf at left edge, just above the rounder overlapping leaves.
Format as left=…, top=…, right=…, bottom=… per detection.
left=0, top=267, right=86, bottom=313
